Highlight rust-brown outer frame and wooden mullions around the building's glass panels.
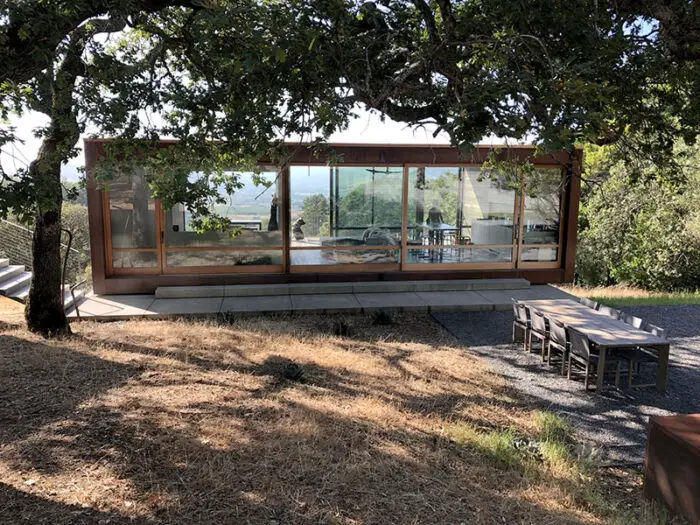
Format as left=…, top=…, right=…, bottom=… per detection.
left=85, top=139, right=582, bottom=293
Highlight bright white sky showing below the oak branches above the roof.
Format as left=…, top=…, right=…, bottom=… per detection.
left=0, top=107, right=516, bottom=181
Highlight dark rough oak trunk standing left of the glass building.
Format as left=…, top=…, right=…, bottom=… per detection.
left=25, top=143, right=71, bottom=337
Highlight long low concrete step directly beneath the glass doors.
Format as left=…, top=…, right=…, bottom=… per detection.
left=155, top=278, right=530, bottom=299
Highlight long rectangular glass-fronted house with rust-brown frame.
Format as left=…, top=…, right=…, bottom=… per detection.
left=85, top=140, right=582, bottom=294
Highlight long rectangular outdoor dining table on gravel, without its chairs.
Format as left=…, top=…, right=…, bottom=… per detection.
left=521, top=299, right=670, bottom=392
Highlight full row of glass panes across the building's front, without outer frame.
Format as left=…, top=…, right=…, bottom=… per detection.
left=109, top=166, right=562, bottom=268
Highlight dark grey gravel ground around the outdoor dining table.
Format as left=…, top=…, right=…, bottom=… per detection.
left=433, top=305, right=700, bottom=464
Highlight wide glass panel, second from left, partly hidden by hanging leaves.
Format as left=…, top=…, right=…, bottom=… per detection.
left=164, top=171, right=282, bottom=268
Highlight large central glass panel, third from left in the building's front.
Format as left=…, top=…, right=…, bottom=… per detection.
left=290, top=166, right=403, bottom=266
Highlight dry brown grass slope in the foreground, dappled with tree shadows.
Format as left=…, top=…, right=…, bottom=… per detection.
left=0, top=314, right=656, bottom=525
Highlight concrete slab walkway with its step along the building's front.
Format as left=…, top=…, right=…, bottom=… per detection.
left=69, top=279, right=571, bottom=321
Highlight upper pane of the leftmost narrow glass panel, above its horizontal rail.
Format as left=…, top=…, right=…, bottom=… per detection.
left=109, top=168, right=156, bottom=250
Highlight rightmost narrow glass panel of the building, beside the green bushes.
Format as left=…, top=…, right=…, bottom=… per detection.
left=520, top=168, right=563, bottom=262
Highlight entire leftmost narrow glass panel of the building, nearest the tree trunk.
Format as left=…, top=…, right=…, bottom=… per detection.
left=109, top=169, right=158, bottom=270
